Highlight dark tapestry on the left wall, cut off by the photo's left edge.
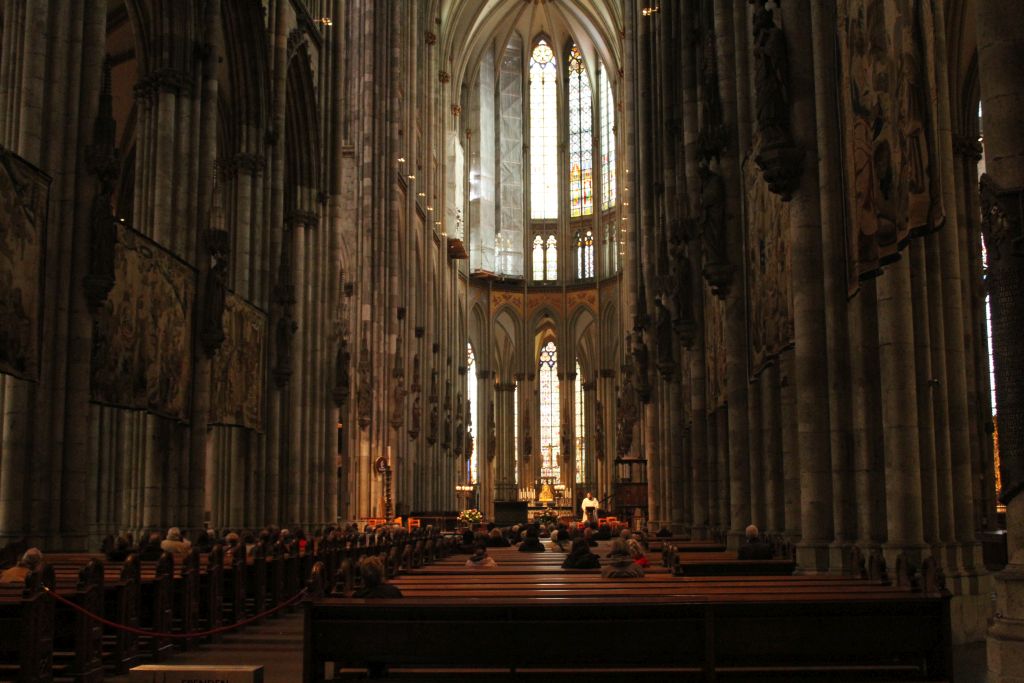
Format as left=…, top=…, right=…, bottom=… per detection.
left=0, top=147, right=50, bottom=382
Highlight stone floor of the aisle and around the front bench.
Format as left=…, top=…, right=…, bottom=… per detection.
left=106, top=612, right=988, bottom=683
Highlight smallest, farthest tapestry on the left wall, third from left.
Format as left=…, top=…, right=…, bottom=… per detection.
left=210, top=293, right=267, bottom=432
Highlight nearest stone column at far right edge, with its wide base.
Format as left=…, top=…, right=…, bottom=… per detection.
left=975, top=0, right=1024, bottom=682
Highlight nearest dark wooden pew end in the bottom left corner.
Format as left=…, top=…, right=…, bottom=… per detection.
left=0, top=565, right=54, bottom=683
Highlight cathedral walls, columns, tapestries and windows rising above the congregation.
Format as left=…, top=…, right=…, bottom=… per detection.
left=0, top=0, right=1024, bottom=681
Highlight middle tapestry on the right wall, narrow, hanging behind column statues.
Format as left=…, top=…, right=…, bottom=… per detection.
left=743, top=150, right=794, bottom=377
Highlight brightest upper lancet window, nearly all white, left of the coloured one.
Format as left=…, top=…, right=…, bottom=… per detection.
left=529, top=38, right=558, bottom=219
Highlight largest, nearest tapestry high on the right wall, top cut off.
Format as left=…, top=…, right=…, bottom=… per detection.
left=838, top=0, right=944, bottom=294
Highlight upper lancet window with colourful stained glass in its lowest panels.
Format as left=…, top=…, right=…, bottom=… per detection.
left=568, top=45, right=594, bottom=218
